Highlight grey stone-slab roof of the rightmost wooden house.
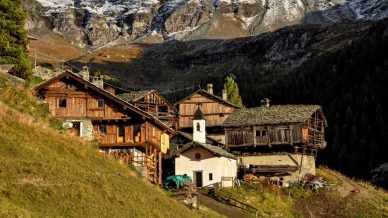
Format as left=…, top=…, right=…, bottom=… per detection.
left=224, top=105, right=321, bottom=127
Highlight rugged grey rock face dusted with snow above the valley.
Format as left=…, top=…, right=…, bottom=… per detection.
left=26, top=0, right=388, bottom=47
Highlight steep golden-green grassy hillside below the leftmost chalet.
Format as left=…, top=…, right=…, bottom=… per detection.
left=0, top=75, right=220, bottom=217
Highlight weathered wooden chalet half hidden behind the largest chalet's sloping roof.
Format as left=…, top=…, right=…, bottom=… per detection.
left=118, top=90, right=177, bottom=129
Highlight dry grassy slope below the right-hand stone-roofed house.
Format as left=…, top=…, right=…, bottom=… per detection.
left=215, top=167, right=388, bottom=218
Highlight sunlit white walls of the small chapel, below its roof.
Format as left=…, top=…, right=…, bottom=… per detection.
left=175, top=147, right=237, bottom=186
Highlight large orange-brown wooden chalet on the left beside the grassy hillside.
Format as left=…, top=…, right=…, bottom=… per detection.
left=34, top=71, right=175, bottom=183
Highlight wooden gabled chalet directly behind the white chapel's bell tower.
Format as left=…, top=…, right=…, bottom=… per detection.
left=175, top=84, right=239, bottom=144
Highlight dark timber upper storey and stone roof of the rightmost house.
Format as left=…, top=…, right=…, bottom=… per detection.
left=224, top=99, right=327, bottom=151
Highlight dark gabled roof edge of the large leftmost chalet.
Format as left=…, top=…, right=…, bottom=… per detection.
left=33, top=70, right=175, bottom=134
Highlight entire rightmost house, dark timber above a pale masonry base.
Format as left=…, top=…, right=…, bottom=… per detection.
left=224, top=99, right=327, bottom=186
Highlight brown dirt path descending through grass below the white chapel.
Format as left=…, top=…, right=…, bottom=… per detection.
left=198, top=194, right=248, bottom=218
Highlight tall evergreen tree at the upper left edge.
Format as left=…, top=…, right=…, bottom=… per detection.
left=0, top=0, right=31, bottom=79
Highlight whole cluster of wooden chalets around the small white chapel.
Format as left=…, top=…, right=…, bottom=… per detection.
left=33, top=67, right=327, bottom=192
